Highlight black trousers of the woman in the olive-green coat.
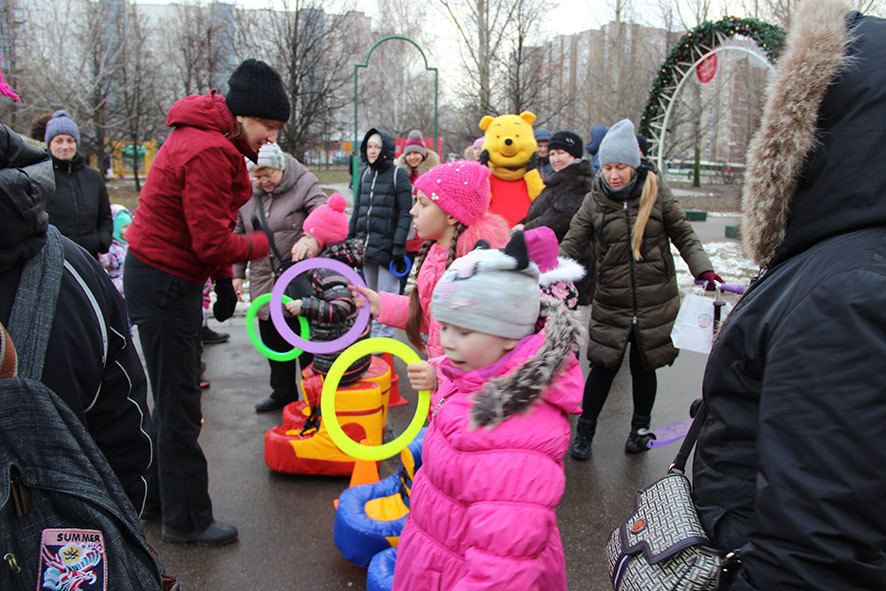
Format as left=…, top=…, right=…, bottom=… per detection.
left=579, top=334, right=658, bottom=435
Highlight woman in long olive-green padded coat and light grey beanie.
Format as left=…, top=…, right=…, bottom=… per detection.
left=560, top=119, right=722, bottom=460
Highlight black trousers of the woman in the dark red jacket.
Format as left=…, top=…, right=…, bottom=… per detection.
left=123, top=253, right=212, bottom=532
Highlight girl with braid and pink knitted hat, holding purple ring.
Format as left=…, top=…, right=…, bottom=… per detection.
left=354, top=160, right=510, bottom=357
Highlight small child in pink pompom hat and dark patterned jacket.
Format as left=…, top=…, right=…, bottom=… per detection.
left=285, top=193, right=370, bottom=386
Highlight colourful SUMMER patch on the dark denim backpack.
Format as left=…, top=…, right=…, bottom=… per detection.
left=37, top=529, right=108, bottom=591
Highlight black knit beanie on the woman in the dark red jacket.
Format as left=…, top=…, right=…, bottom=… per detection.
left=225, top=59, right=292, bottom=121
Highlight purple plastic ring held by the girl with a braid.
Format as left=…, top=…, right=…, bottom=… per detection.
left=270, top=258, right=369, bottom=354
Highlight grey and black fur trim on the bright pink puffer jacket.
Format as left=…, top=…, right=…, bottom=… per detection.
left=471, top=297, right=582, bottom=429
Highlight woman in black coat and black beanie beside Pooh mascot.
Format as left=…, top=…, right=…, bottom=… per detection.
left=523, top=131, right=597, bottom=305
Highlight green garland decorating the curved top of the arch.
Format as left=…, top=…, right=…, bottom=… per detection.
left=639, top=16, right=785, bottom=165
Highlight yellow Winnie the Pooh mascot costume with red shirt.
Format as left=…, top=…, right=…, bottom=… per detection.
left=480, top=111, right=544, bottom=227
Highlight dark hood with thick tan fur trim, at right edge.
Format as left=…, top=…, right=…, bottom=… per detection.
left=742, top=0, right=886, bottom=267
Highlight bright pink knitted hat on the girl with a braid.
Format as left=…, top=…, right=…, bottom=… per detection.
left=415, top=160, right=489, bottom=226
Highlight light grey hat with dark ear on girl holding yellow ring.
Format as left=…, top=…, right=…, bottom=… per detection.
left=431, top=232, right=541, bottom=339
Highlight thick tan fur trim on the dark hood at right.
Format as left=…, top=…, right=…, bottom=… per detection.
left=741, top=0, right=850, bottom=266
